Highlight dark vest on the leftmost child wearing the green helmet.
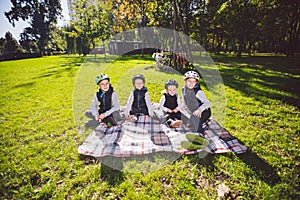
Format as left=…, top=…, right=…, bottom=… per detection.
left=97, top=85, right=114, bottom=114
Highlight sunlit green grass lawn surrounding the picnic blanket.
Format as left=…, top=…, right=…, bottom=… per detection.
left=0, top=55, right=300, bottom=199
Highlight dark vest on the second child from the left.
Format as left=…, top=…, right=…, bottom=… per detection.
left=131, top=87, right=149, bottom=115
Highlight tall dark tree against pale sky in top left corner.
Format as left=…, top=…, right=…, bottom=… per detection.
left=5, top=0, right=61, bottom=55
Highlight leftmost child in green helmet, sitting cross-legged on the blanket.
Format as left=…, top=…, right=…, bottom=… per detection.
left=85, top=74, right=120, bottom=126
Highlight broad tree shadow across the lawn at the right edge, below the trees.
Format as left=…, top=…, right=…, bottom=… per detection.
left=215, top=56, right=300, bottom=109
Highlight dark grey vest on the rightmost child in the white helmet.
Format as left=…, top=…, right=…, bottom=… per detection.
left=182, top=83, right=203, bottom=112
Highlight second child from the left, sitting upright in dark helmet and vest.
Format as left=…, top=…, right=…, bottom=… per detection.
left=125, top=74, right=154, bottom=122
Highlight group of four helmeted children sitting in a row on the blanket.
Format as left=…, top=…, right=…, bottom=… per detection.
left=86, top=71, right=211, bottom=133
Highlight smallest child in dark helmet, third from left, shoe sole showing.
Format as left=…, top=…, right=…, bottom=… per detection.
left=159, top=79, right=182, bottom=128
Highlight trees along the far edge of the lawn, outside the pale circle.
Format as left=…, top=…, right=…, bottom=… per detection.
left=0, top=0, right=300, bottom=57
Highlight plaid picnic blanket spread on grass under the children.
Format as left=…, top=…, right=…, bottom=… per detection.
left=78, top=115, right=247, bottom=157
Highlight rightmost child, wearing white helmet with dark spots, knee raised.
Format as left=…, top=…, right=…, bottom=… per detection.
left=182, top=71, right=211, bottom=133
